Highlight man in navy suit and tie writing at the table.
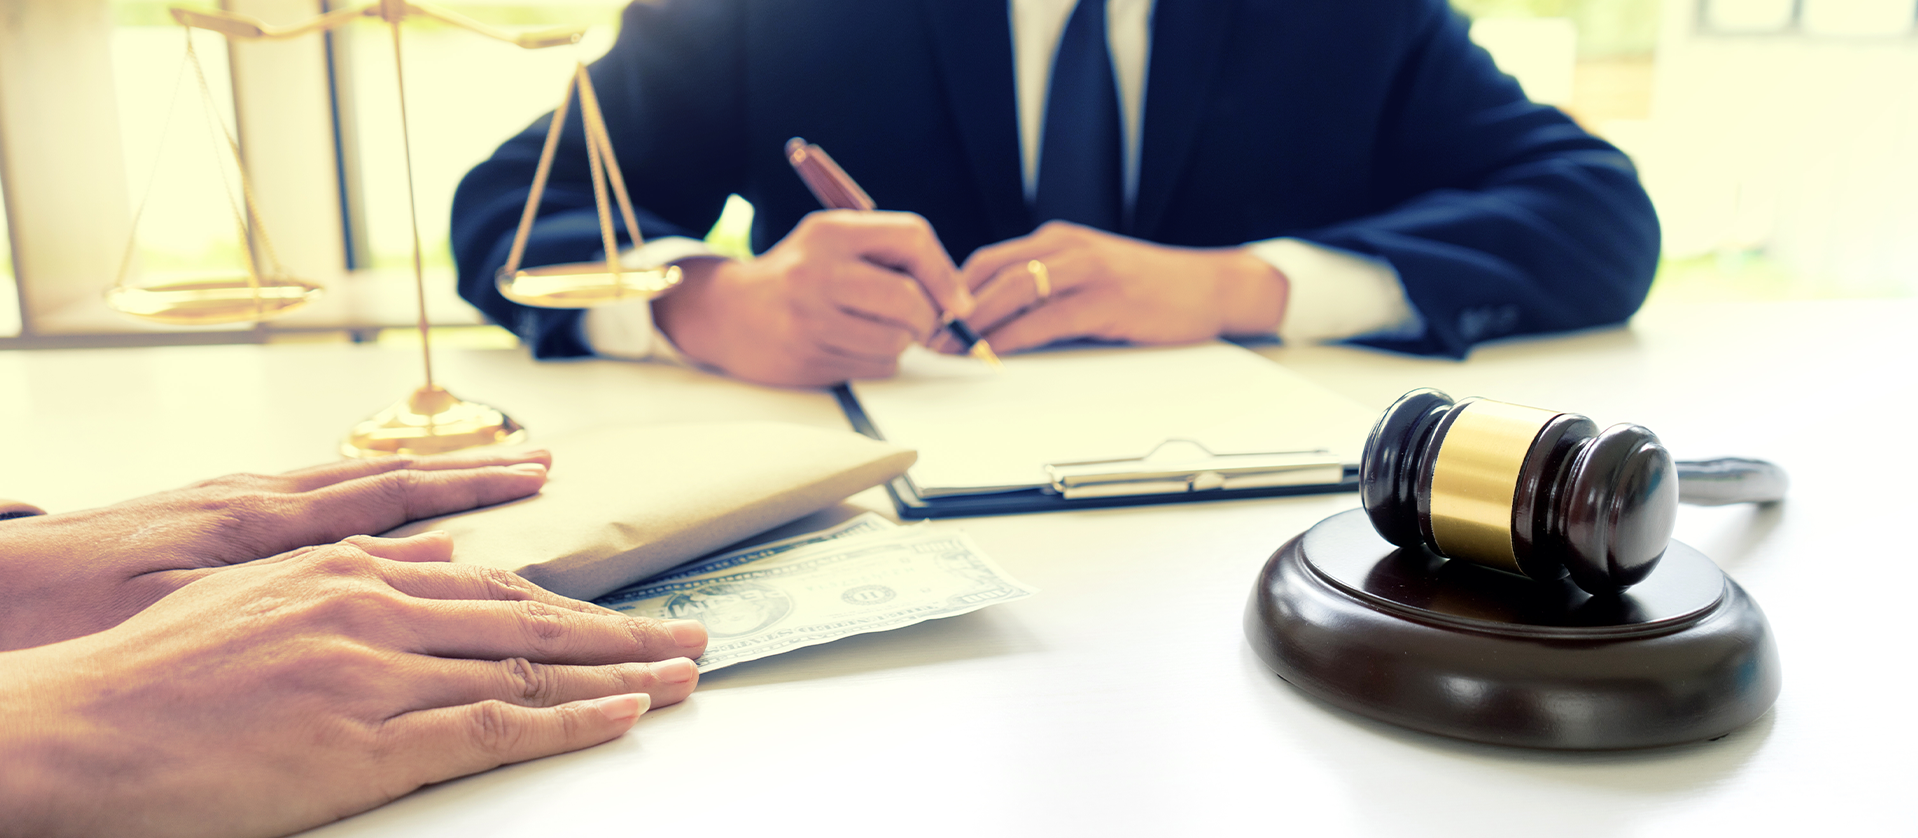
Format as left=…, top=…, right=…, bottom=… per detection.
left=453, top=0, right=1659, bottom=385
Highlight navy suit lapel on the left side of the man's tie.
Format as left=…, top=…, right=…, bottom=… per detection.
left=924, top=0, right=1032, bottom=240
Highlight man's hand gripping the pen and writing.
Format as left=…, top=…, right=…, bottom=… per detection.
left=652, top=209, right=972, bottom=385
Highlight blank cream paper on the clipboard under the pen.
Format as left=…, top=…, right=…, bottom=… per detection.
left=852, top=341, right=1377, bottom=497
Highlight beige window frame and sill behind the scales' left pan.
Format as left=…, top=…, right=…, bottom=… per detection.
left=0, top=0, right=485, bottom=349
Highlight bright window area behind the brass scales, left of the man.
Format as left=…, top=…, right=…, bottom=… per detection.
left=0, top=0, right=623, bottom=343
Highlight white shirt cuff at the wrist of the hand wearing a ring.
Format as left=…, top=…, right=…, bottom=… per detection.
left=1247, top=238, right=1425, bottom=343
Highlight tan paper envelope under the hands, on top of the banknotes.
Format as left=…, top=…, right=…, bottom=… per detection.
left=386, top=422, right=915, bottom=600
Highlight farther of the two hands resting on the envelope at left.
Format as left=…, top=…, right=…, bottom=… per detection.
left=0, top=451, right=552, bottom=650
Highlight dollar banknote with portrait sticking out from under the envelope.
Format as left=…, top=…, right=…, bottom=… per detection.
left=595, top=525, right=1034, bottom=671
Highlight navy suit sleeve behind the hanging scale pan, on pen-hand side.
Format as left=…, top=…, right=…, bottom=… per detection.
left=453, top=0, right=744, bottom=359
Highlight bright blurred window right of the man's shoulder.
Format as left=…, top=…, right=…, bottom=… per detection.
left=1454, top=0, right=1918, bottom=297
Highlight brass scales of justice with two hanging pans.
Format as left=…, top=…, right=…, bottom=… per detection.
left=105, top=0, right=681, bottom=456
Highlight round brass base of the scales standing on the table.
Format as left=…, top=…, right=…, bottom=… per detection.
left=339, top=387, right=526, bottom=456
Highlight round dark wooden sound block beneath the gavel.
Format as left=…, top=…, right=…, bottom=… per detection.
left=1245, top=510, right=1778, bottom=750
